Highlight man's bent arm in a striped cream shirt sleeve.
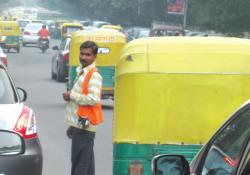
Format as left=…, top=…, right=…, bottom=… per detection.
left=70, top=72, right=102, bottom=106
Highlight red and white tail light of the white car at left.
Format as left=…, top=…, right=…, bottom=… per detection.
left=14, top=107, right=37, bottom=139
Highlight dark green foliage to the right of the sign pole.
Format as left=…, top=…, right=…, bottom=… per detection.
left=188, top=0, right=250, bottom=35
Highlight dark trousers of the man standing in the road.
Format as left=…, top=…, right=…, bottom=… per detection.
left=71, top=128, right=95, bottom=175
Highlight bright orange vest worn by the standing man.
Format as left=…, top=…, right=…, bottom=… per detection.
left=77, top=67, right=103, bottom=125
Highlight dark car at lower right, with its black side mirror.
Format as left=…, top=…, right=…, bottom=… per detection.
left=152, top=101, right=250, bottom=175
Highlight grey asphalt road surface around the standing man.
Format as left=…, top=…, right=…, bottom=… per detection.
left=7, top=40, right=113, bottom=175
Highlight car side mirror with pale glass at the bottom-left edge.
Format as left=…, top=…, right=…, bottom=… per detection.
left=0, top=130, right=24, bottom=156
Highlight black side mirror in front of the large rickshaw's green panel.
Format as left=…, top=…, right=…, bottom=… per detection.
left=151, top=155, right=190, bottom=175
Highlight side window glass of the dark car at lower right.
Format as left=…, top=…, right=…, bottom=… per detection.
left=202, top=109, right=250, bottom=175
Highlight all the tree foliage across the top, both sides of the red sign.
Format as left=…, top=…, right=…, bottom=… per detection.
left=0, top=0, right=250, bottom=35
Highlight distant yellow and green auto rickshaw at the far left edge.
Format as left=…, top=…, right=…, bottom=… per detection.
left=0, top=21, right=20, bottom=53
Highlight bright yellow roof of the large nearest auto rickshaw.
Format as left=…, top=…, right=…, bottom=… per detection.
left=117, top=37, right=250, bottom=76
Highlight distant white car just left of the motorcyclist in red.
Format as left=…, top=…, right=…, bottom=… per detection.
left=23, top=23, right=43, bottom=46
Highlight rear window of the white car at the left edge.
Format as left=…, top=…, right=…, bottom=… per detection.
left=0, top=68, right=17, bottom=104
